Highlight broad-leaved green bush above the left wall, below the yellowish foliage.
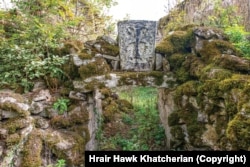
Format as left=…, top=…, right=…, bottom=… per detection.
left=0, top=44, right=68, bottom=91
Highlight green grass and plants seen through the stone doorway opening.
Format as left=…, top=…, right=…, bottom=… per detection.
left=100, top=87, right=165, bottom=151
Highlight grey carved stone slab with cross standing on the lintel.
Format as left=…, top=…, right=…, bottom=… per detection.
left=118, top=20, right=156, bottom=71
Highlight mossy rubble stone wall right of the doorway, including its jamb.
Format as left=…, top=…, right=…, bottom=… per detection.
left=156, top=27, right=250, bottom=150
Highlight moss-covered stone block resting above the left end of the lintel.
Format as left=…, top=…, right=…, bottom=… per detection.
left=78, top=58, right=110, bottom=79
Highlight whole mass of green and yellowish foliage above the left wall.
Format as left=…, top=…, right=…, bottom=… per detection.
left=0, top=0, right=115, bottom=91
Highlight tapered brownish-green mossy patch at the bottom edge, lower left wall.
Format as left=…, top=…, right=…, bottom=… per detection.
left=21, top=130, right=43, bottom=167
